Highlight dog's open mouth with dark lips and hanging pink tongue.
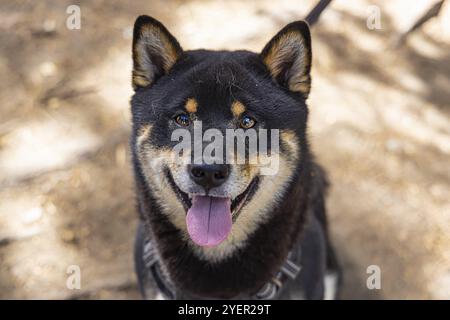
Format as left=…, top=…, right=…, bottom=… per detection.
left=166, top=170, right=259, bottom=246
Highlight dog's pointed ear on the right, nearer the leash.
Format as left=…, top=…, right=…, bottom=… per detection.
left=260, top=21, right=311, bottom=99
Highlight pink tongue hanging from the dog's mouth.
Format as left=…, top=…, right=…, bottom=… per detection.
left=186, top=196, right=232, bottom=246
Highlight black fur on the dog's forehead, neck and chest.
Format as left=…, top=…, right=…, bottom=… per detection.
left=131, top=18, right=340, bottom=298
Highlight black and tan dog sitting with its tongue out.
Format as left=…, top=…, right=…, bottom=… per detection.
left=131, top=16, right=339, bottom=299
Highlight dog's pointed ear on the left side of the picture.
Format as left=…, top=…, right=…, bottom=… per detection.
left=132, top=16, right=183, bottom=90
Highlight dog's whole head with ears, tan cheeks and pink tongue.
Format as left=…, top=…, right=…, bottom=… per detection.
left=131, top=16, right=311, bottom=257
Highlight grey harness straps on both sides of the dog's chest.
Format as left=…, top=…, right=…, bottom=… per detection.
left=143, top=232, right=302, bottom=300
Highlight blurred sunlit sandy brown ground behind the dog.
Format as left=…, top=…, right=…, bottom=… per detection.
left=0, top=0, right=450, bottom=299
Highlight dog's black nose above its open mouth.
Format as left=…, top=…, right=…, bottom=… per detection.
left=188, top=164, right=229, bottom=191
